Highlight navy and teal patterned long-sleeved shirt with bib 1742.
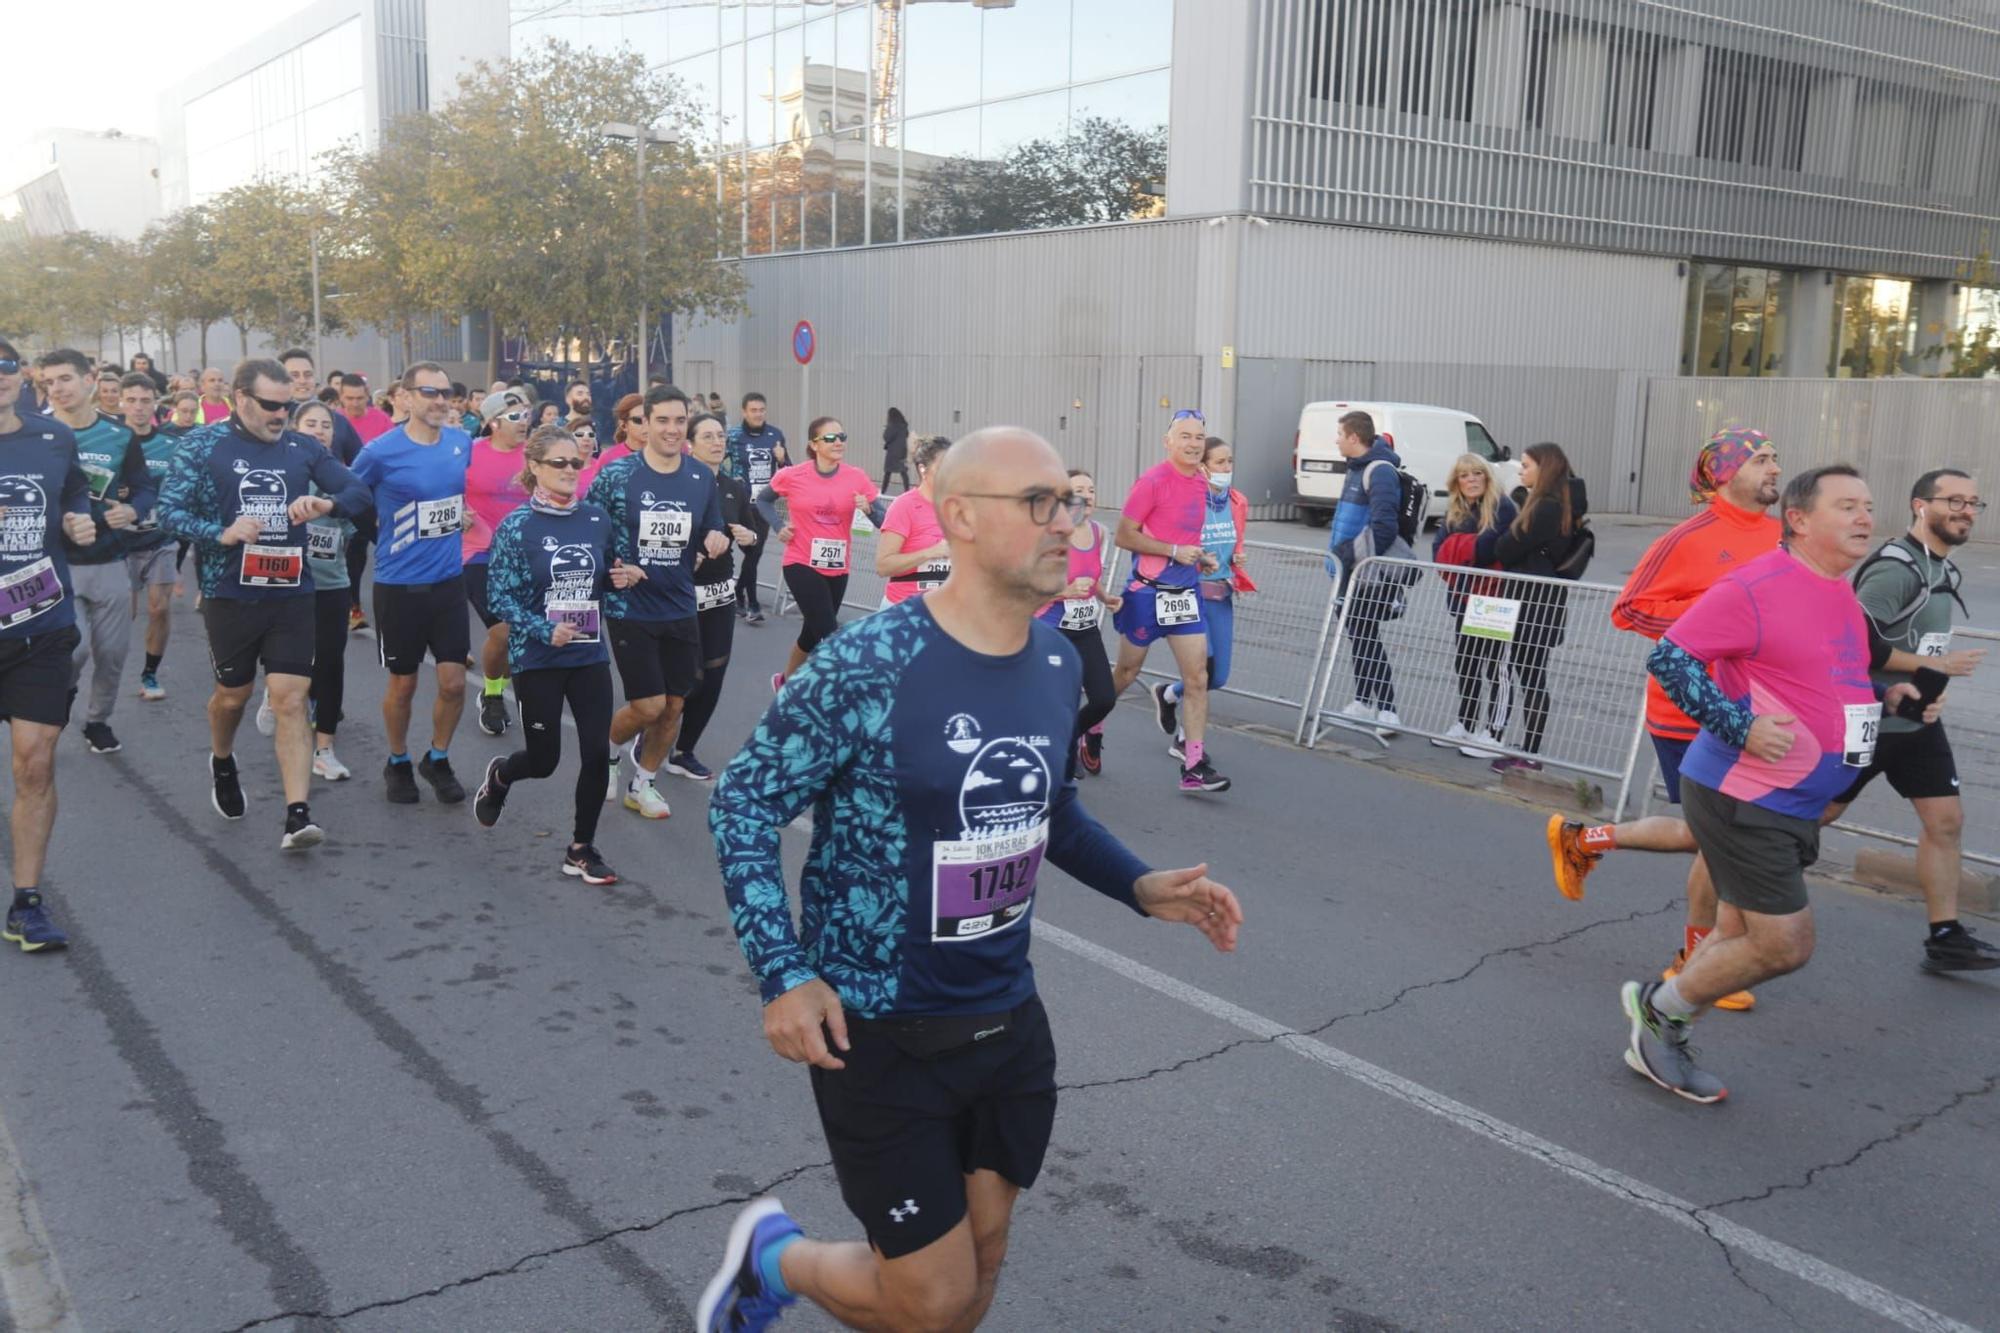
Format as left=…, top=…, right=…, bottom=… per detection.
left=708, top=598, right=1148, bottom=1017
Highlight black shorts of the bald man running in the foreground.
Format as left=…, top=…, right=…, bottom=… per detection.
left=812, top=984, right=1056, bottom=1259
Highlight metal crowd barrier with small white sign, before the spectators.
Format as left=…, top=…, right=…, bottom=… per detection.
left=1302, top=556, right=1652, bottom=819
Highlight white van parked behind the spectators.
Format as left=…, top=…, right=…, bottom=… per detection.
left=1292, top=402, right=1520, bottom=528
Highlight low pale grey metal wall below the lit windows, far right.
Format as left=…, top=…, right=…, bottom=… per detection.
left=1640, top=378, right=2000, bottom=530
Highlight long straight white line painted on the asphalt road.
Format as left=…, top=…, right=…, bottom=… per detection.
left=1034, top=919, right=1978, bottom=1333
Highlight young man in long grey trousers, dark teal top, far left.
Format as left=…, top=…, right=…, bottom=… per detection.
left=38, top=348, right=158, bottom=755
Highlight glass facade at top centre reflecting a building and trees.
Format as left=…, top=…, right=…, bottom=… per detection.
left=510, top=0, right=1174, bottom=254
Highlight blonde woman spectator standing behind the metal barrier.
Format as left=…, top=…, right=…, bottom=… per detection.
left=1430, top=454, right=1518, bottom=759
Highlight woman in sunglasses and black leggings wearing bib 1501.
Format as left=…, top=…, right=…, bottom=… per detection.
left=472, top=426, right=620, bottom=885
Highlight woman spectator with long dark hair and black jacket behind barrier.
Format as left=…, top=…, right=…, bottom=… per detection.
left=1474, top=444, right=1590, bottom=773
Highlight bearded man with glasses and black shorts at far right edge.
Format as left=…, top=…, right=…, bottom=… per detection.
left=1820, top=468, right=2000, bottom=973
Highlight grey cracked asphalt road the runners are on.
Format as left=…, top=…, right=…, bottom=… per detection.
left=0, top=580, right=2000, bottom=1333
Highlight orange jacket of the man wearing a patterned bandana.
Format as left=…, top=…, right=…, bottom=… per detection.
left=1612, top=496, right=1780, bottom=741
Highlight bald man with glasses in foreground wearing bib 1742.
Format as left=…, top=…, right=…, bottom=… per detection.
left=696, top=426, right=1242, bottom=1333
